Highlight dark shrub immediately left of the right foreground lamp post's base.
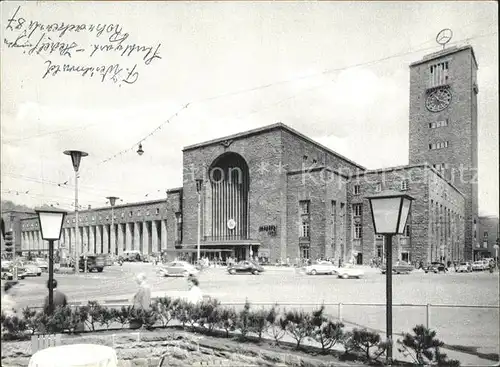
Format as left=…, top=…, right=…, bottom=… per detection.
left=344, top=329, right=387, bottom=362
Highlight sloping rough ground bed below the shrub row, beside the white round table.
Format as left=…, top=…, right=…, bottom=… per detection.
left=2, top=328, right=362, bottom=367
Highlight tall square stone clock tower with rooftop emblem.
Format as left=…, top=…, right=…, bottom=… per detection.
left=409, top=46, right=478, bottom=260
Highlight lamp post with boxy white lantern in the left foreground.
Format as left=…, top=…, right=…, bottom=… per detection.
left=35, top=209, right=66, bottom=313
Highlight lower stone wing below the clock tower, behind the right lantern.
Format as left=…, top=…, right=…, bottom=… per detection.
left=347, top=164, right=465, bottom=264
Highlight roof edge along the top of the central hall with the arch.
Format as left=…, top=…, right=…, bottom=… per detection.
left=182, top=122, right=366, bottom=170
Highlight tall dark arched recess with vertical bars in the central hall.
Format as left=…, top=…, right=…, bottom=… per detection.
left=207, top=152, right=250, bottom=242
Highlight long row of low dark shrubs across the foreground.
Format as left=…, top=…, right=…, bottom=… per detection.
left=1, top=297, right=460, bottom=366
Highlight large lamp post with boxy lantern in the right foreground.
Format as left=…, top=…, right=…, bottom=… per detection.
left=367, top=191, right=413, bottom=364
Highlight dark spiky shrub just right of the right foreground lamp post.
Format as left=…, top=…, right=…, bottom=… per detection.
left=398, top=325, right=460, bottom=366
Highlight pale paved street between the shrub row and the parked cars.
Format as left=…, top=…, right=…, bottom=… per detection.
left=2, top=263, right=499, bottom=360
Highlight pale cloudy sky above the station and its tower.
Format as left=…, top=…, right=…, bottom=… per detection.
left=0, top=1, right=499, bottom=215
